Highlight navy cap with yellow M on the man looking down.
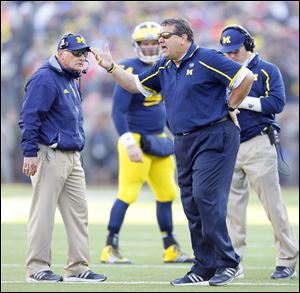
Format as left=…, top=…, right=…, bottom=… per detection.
left=220, top=28, right=246, bottom=53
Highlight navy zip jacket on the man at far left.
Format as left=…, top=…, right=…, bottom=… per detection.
left=19, top=56, right=85, bottom=157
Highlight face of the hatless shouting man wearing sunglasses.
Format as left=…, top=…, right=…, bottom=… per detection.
left=158, top=25, right=183, bottom=60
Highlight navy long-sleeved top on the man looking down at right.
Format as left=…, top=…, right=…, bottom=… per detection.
left=238, top=55, right=286, bottom=142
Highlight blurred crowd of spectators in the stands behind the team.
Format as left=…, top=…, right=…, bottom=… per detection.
left=1, top=1, right=299, bottom=185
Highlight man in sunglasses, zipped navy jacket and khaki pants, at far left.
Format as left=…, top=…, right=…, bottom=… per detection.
left=19, top=34, right=106, bottom=282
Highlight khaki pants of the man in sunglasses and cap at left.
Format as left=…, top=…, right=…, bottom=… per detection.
left=26, top=145, right=89, bottom=276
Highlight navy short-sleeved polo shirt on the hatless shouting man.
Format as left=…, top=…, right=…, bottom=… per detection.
left=137, top=43, right=242, bottom=134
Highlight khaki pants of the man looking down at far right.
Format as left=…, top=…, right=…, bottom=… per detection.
left=227, top=135, right=299, bottom=267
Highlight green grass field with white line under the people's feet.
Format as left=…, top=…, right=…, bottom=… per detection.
left=1, top=185, right=299, bottom=292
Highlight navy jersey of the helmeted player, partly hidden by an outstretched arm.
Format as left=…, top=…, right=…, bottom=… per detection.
left=112, top=58, right=166, bottom=136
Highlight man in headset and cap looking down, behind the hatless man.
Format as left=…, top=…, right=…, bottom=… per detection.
left=220, top=25, right=299, bottom=279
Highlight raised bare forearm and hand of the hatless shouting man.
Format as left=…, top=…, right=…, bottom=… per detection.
left=91, top=44, right=140, bottom=94
